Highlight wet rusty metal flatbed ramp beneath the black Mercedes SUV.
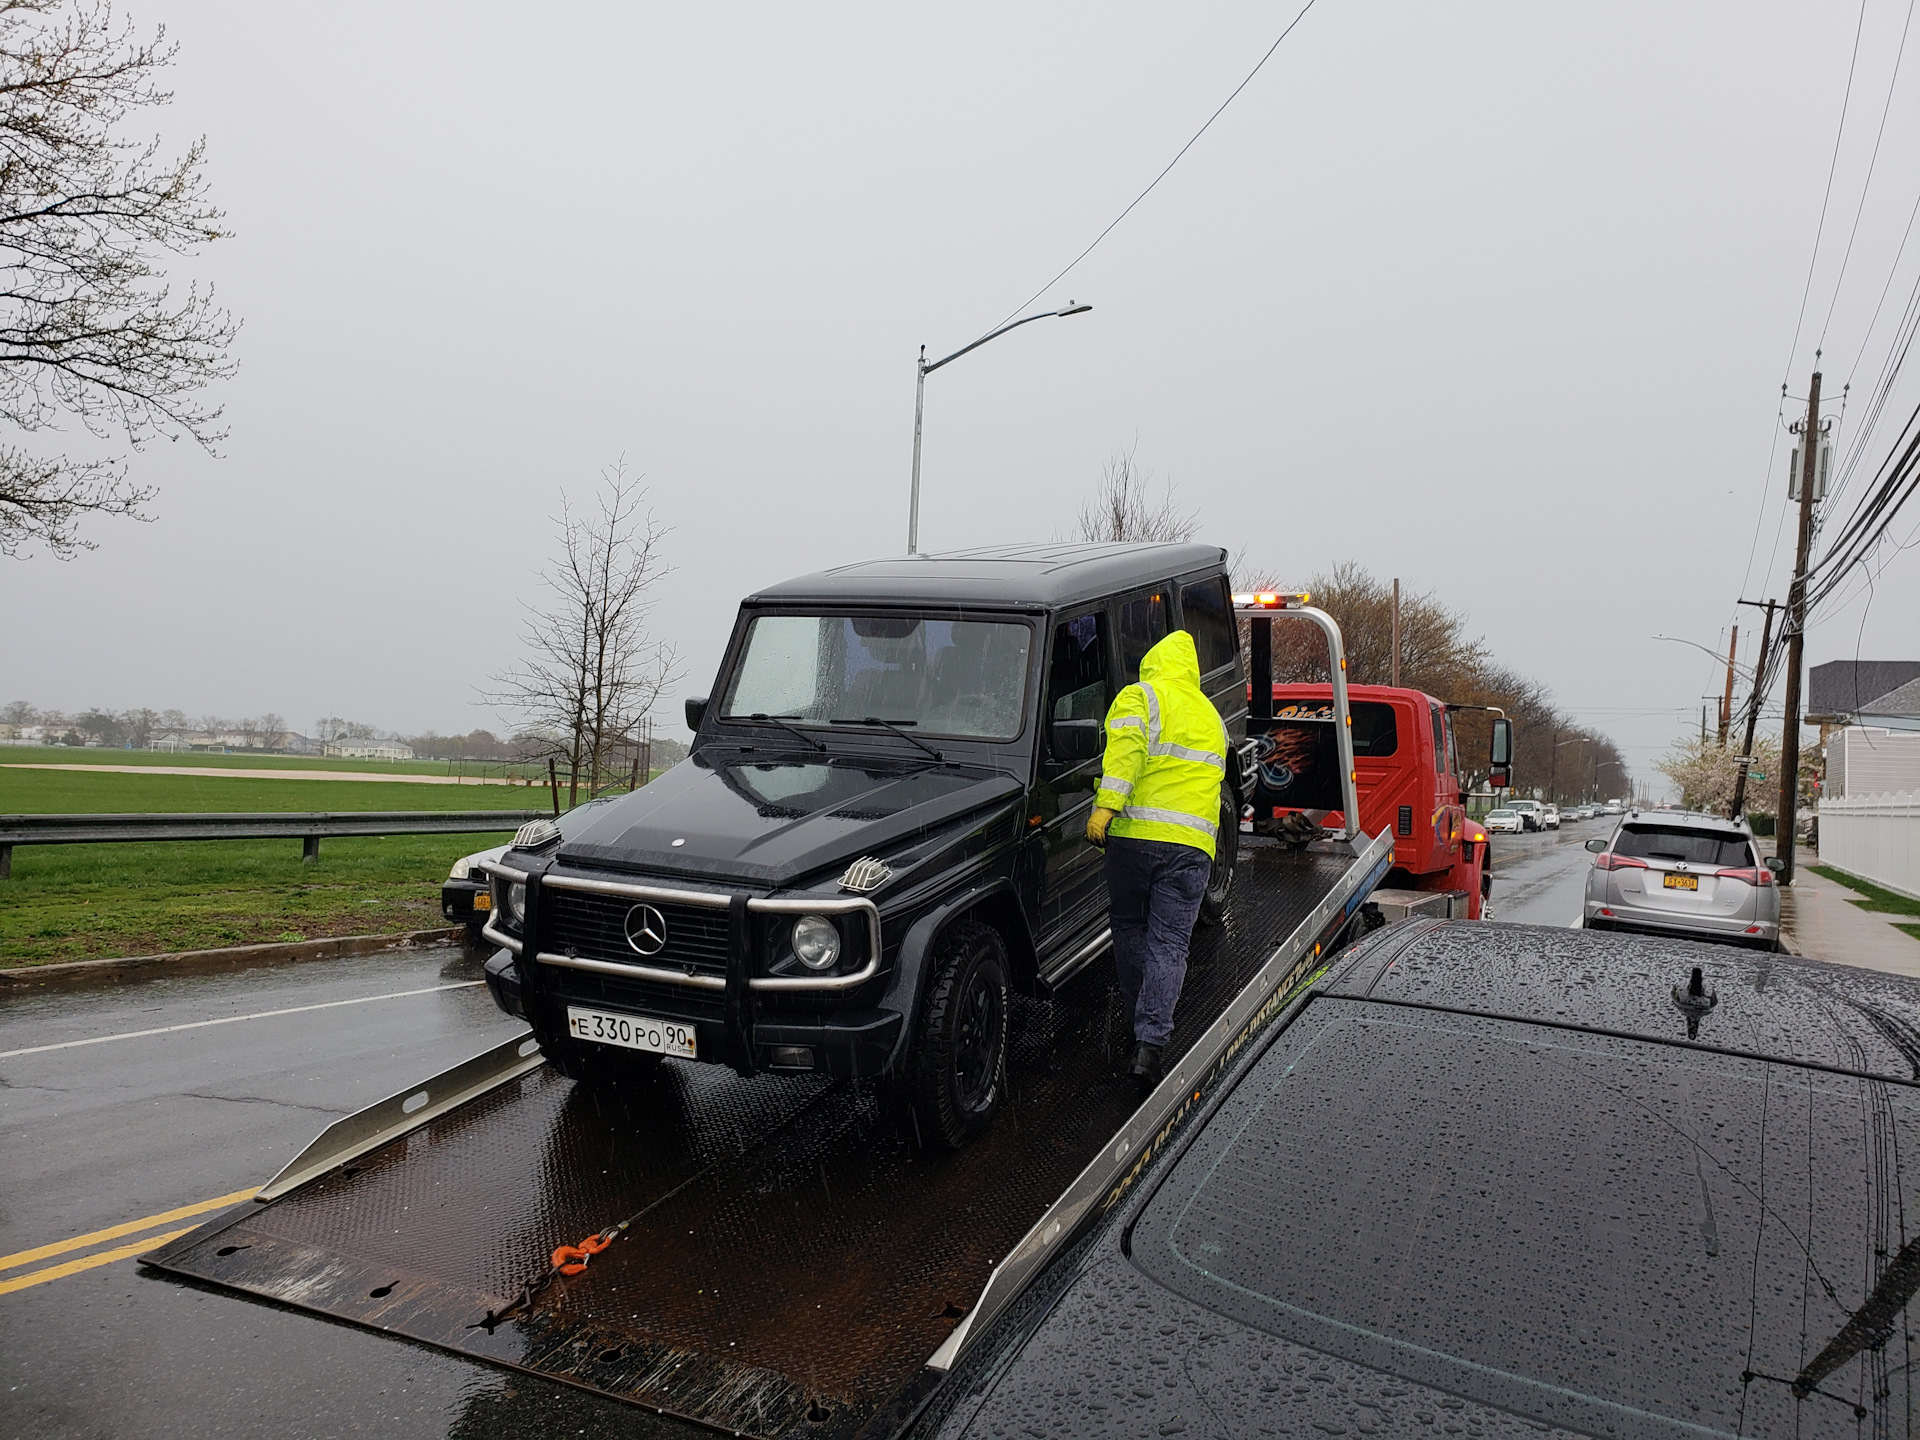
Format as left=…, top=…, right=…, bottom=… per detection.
left=144, top=847, right=1384, bottom=1436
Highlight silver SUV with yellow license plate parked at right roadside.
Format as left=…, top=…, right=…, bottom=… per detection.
left=1582, top=810, right=1780, bottom=950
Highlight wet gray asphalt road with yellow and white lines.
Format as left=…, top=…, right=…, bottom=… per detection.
left=0, top=820, right=1613, bottom=1440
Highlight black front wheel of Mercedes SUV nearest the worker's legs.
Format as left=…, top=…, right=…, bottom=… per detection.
left=902, top=922, right=1006, bottom=1150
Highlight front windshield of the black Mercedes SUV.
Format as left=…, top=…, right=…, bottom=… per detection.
left=720, top=614, right=1033, bottom=739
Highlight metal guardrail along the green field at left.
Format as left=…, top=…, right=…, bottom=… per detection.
left=0, top=810, right=547, bottom=879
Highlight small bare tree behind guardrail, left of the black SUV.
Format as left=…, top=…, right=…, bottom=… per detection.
left=486, top=461, right=678, bottom=801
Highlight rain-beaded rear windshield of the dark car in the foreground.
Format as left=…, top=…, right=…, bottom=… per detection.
left=1129, top=998, right=1920, bottom=1440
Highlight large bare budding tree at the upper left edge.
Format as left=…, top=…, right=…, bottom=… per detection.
left=0, top=0, right=236, bottom=557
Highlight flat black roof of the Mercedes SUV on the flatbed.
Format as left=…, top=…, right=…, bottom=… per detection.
left=747, top=543, right=1227, bottom=609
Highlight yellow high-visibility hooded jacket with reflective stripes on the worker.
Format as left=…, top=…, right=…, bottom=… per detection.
left=1094, top=630, right=1227, bottom=858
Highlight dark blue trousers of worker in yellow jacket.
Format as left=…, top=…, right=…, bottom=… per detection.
left=1106, top=835, right=1213, bottom=1044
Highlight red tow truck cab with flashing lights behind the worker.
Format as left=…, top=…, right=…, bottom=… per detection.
left=1235, top=591, right=1513, bottom=920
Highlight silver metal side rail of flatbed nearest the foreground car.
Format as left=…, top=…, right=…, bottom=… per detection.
left=927, top=829, right=1394, bottom=1371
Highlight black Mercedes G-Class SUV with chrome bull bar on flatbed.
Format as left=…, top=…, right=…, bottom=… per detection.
left=486, top=545, right=1246, bottom=1146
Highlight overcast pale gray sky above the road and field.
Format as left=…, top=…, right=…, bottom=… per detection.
left=0, top=0, right=1920, bottom=794
